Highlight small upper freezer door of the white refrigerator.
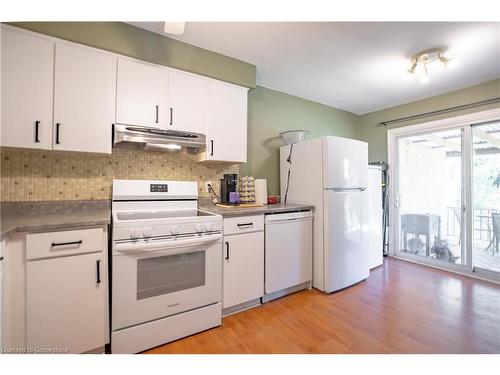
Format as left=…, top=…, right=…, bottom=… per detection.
left=323, top=137, right=368, bottom=188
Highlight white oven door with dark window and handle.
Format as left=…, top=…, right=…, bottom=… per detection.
left=112, top=233, right=222, bottom=331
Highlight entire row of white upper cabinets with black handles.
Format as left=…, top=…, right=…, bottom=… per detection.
left=0, top=25, right=248, bottom=163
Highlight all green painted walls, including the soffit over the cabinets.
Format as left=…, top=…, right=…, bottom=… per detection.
left=10, top=22, right=500, bottom=194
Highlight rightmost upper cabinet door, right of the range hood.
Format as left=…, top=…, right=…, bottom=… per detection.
left=206, top=81, right=247, bottom=163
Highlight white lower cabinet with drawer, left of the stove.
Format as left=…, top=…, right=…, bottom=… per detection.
left=12, top=228, right=109, bottom=353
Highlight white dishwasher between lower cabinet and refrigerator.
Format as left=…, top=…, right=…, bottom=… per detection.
left=263, top=211, right=313, bottom=302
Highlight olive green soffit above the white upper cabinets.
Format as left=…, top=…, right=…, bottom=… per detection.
left=9, top=22, right=256, bottom=88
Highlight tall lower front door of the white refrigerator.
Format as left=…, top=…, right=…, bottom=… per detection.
left=324, top=190, right=369, bottom=293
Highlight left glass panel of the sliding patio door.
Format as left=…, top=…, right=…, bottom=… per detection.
left=397, top=128, right=466, bottom=265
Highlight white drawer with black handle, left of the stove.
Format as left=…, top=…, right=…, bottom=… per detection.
left=26, top=228, right=104, bottom=260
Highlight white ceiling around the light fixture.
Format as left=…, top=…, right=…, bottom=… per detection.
left=130, top=22, right=500, bottom=114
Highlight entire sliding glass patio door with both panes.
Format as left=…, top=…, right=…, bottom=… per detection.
left=392, top=117, right=500, bottom=279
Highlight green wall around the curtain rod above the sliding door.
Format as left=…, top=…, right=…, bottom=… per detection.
left=359, top=80, right=500, bottom=161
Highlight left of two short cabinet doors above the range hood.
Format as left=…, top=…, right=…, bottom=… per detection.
left=116, top=59, right=168, bottom=128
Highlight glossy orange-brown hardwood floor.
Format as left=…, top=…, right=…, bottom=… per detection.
left=146, top=258, right=500, bottom=353
